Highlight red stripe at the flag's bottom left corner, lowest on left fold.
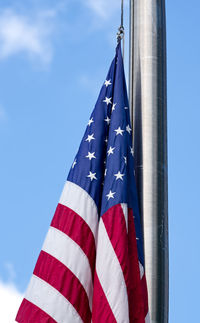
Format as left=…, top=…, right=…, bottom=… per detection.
left=15, top=298, right=56, bottom=323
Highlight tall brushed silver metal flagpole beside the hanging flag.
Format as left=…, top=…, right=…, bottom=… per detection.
left=129, top=0, right=168, bottom=323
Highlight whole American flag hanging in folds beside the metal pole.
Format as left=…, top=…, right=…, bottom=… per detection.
left=16, top=43, right=149, bottom=323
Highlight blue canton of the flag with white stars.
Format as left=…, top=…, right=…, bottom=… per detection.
left=67, top=43, right=144, bottom=265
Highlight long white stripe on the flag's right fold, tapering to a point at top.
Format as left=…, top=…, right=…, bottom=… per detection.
left=96, top=219, right=129, bottom=323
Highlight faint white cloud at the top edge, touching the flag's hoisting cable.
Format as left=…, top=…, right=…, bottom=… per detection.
left=83, top=0, right=128, bottom=19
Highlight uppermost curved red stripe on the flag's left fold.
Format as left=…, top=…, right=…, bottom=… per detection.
left=51, top=202, right=96, bottom=276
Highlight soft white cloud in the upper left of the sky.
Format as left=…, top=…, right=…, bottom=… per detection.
left=0, top=9, right=55, bottom=63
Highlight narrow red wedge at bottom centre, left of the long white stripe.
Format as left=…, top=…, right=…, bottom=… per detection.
left=92, top=271, right=117, bottom=323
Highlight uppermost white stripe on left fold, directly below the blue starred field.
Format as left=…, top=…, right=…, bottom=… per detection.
left=59, top=181, right=98, bottom=241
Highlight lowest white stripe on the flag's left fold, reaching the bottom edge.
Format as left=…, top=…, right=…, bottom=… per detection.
left=25, top=275, right=83, bottom=323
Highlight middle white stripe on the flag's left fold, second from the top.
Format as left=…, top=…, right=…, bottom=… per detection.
left=42, top=227, right=93, bottom=308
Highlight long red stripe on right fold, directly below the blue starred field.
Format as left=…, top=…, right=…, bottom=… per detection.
left=102, top=204, right=146, bottom=323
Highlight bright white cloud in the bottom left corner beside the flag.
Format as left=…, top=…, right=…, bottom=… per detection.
left=0, top=280, right=23, bottom=323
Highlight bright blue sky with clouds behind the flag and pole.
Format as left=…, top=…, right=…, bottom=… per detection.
left=0, top=0, right=200, bottom=323
